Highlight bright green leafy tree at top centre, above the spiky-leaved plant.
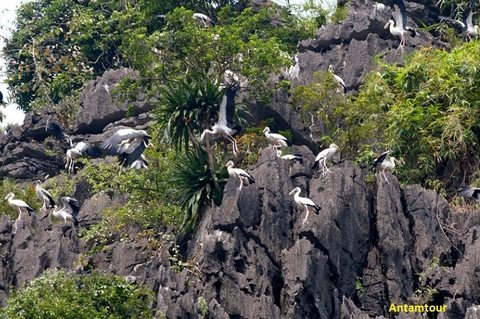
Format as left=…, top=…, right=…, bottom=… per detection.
left=121, top=5, right=300, bottom=103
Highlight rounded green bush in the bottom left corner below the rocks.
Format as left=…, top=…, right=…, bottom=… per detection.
left=0, top=270, right=154, bottom=319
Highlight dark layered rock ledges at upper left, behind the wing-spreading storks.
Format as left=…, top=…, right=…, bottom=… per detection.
left=0, top=69, right=153, bottom=180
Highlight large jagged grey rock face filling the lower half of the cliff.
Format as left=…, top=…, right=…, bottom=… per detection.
left=0, top=137, right=480, bottom=318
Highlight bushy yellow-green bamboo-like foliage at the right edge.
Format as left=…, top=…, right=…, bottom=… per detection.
left=379, top=42, right=480, bottom=190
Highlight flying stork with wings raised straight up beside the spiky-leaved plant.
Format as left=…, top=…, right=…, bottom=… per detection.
left=200, top=83, right=241, bottom=156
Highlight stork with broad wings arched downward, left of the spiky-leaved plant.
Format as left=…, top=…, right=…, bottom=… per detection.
left=100, top=128, right=151, bottom=167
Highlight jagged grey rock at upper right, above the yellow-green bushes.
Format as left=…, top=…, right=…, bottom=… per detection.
left=262, top=0, right=445, bottom=152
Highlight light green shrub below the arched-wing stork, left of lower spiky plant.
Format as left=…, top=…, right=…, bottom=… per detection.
left=80, top=142, right=180, bottom=230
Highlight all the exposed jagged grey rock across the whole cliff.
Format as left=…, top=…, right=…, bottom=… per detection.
left=0, top=1, right=480, bottom=319
